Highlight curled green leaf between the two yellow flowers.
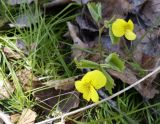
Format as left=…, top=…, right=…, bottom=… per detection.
left=105, top=53, right=125, bottom=72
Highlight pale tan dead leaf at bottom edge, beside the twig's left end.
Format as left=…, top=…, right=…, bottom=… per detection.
left=17, top=109, right=37, bottom=124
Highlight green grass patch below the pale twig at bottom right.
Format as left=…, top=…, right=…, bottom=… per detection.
left=78, top=90, right=160, bottom=124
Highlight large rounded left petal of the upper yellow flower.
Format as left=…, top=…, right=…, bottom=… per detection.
left=112, top=19, right=127, bottom=37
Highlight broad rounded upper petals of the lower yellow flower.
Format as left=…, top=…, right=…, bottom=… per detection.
left=82, top=70, right=107, bottom=89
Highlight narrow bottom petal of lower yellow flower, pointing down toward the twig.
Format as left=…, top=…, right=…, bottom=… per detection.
left=89, top=87, right=99, bottom=102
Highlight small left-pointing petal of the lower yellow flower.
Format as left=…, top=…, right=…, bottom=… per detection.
left=75, top=81, right=88, bottom=94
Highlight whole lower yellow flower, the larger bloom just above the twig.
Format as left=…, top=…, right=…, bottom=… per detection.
left=75, top=70, right=107, bottom=102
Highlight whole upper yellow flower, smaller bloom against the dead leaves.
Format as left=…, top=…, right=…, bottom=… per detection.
left=112, top=19, right=136, bottom=40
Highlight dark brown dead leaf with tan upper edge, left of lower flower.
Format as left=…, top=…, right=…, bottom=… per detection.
left=34, top=75, right=81, bottom=115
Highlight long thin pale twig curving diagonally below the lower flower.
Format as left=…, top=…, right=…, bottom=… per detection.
left=36, top=66, right=160, bottom=124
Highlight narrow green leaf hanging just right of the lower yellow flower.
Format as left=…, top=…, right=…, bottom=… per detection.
left=102, top=69, right=115, bottom=94
